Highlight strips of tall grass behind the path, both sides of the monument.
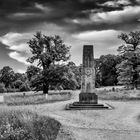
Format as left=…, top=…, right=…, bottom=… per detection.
left=1, top=87, right=140, bottom=105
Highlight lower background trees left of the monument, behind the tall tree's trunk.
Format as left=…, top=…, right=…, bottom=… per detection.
left=0, top=62, right=81, bottom=92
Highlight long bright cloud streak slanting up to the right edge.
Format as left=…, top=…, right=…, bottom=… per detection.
left=67, top=6, right=140, bottom=32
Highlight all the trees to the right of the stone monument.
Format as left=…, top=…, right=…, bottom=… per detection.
left=96, top=31, right=140, bottom=89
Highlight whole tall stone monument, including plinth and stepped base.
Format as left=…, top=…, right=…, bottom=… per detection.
left=66, top=45, right=108, bottom=110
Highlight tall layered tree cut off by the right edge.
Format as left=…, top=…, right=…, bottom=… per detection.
left=117, top=31, right=140, bottom=89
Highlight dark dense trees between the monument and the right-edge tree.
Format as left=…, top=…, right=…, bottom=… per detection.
left=95, top=54, right=121, bottom=87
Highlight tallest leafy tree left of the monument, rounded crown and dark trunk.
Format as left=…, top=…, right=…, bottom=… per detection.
left=27, top=32, right=70, bottom=94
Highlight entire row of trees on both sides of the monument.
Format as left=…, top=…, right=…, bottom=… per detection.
left=0, top=31, right=140, bottom=94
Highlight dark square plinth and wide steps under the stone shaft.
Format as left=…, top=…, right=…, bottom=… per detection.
left=65, top=93, right=109, bottom=110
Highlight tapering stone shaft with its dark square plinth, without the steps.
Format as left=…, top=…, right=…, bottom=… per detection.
left=79, top=45, right=97, bottom=104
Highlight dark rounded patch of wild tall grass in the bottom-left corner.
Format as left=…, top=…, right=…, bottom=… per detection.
left=0, top=111, right=60, bottom=140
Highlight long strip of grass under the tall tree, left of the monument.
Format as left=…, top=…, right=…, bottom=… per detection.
left=4, top=91, right=71, bottom=105
